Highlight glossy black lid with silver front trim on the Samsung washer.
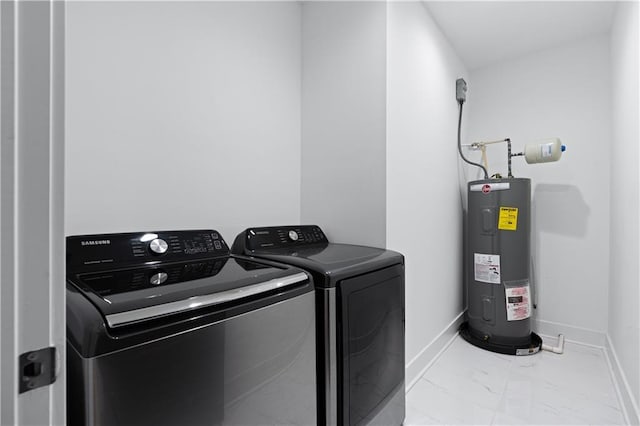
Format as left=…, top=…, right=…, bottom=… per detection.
left=70, top=257, right=309, bottom=328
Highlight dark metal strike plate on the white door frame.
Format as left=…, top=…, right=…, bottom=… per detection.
left=19, top=347, right=56, bottom=393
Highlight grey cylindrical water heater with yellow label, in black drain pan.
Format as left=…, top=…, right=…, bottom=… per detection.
left=460, top=178, right=542, bottom=355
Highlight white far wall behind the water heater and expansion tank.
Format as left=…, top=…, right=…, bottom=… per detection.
left=465, top=35, right=611, bottom=345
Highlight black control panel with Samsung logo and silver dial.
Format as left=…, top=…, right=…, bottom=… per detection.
left=67, top=230, right=229, bottom=272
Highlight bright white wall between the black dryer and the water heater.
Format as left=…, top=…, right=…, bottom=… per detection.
left=387, top=2, right=468, bottom=382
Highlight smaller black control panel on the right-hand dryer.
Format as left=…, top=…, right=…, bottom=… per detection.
left=244, top=225, right=329, bottom=251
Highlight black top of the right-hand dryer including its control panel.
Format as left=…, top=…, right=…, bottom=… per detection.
left=231, top=225, right=404, bottom=287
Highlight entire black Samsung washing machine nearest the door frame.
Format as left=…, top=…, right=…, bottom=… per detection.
left=66, top=230, right=317, bottom=425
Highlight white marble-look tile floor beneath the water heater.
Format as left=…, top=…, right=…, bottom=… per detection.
left=404, top=336, right=625, bottom=426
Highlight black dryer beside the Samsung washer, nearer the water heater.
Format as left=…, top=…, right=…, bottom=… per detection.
left=232, top=225, right=405, bottom=426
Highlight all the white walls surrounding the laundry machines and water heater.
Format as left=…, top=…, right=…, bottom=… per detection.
left=66, top=2, right=640, bottom=412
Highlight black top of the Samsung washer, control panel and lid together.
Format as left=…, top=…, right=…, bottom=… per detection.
left=67, top=230, right=309, bottom=329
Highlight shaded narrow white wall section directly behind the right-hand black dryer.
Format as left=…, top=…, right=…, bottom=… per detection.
left=301, top=2, right=386, bottom=247
